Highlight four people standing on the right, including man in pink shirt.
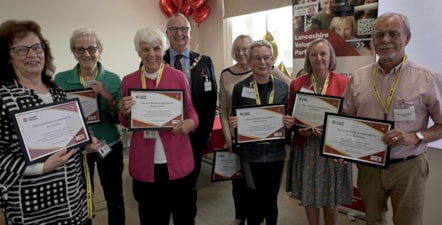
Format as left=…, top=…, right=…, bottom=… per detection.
left=219, top=13, right=442, bottom=225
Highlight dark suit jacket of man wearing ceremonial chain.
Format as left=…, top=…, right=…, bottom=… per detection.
left=164, top=50, right=217, bottom=151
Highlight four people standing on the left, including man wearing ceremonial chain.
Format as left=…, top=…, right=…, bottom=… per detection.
left=0, top=14, right=217, bottom=225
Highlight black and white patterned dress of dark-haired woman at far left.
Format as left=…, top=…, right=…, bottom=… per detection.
left=0, top=81, right=88, bottom=225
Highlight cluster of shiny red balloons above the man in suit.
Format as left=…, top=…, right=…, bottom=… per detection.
left=160, top=0, right=210, bottom=25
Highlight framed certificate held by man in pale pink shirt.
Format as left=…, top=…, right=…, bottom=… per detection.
left=320, top=113, right=394, bottom=168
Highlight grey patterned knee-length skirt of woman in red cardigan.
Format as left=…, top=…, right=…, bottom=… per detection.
left=287, top=136, right=353, bottom=207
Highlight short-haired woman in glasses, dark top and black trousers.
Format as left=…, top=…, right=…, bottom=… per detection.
left=229, top=40, right=288, bottom=225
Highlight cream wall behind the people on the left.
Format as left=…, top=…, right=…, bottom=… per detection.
left=0, top=0, right=224, bottom=79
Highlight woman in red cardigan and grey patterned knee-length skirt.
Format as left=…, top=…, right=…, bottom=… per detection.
left=284, top=39, right=353, bottom=225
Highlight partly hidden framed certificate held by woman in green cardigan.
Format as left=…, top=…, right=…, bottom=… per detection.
left=65, top=88, right=101, bottom=124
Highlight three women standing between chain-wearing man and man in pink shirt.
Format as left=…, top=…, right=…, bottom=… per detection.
left=219, top=27, right=353, bottom=225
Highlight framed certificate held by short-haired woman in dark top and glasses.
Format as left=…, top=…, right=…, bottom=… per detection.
left=235, top=104, right=285, bottom=144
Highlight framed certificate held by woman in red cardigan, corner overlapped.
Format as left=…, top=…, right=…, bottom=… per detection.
left=292, top=92, right=343, bottom=128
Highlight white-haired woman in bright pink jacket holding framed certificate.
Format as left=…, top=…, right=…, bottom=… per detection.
left=119, top=27, right=199, bottom=225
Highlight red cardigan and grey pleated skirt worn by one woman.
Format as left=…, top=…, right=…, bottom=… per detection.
left=286, top=72, right=353, bottom=207
